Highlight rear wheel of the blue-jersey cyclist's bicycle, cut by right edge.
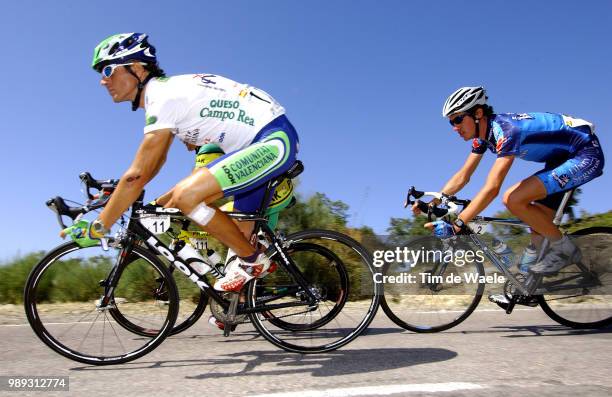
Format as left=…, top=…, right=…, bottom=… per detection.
left=538, top=227, right=612, bottom=328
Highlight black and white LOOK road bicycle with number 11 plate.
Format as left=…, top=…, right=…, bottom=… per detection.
left=24, top=162, right=381, bottom=365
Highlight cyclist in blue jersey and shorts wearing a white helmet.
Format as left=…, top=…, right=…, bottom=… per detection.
left=413, top=87, right=604, bottom=282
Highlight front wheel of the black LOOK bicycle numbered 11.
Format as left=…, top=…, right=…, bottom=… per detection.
left=24, top=242, right=178, bottom=365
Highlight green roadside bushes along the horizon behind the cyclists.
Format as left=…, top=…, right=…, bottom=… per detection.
left=0, top=198, right=612, bottom=304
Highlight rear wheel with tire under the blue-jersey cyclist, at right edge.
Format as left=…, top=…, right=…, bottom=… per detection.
left=538, top=226, right=612, bottom=329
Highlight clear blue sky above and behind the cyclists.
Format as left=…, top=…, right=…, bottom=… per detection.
left=0, top=0, right=612, bottom=260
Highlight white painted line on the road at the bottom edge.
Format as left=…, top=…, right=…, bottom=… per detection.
left=254, top=382, right=485, bottom=397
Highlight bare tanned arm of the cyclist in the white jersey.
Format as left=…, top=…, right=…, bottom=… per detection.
left=99, top=129, right=173, bottom=228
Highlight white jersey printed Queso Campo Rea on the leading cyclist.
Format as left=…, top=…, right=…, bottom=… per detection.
left=144, top=74, right=285, bottom=153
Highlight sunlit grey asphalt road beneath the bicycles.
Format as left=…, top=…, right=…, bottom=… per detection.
left=0, top=304, right=612, bottom=397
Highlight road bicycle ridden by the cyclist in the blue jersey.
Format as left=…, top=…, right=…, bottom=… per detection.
left=379, top=187, right=612, bottom=332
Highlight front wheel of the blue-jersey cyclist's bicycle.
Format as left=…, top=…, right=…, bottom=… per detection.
left=380, top=236, right=485, bottom=333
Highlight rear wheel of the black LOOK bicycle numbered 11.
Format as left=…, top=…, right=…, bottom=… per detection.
left=247, top=230, right=380, bottom=353
